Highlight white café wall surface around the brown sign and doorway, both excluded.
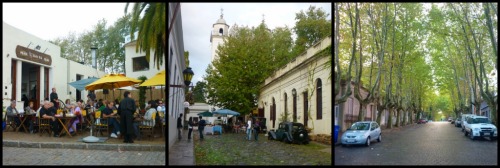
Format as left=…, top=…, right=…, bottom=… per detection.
left=2, top=22, right=104, bottom=107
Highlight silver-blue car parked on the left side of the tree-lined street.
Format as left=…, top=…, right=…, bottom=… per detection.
left=341, top=121, right=382, bottom=146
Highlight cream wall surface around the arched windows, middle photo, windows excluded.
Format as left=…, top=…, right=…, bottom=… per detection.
left=258, top=38, right=332, bottom=134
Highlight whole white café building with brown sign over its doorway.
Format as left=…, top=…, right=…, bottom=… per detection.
left=2, top=22, right=105, bottom=109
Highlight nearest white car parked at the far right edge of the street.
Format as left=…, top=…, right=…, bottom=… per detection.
left=464, top=116, right=497, bottom=140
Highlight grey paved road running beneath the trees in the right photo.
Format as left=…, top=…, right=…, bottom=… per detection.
left=334, top=122, right=498, bottom=165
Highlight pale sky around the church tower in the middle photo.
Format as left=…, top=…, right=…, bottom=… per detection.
left=181, top=3, right=332, bottom=84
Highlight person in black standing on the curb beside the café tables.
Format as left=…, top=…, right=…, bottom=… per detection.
left=118, top=91, right=137, bottom=143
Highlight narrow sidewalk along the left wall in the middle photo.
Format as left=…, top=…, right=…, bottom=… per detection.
left=168, top=130, right=195, bottom=165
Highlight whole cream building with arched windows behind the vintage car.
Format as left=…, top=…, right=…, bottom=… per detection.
left=258, top=37, right=332, bottom=134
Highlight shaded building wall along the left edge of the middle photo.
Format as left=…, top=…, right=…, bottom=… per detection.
left=167, top=3, right=186, bottom=149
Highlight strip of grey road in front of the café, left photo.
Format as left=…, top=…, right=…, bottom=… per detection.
left=2, top=147, right=166, bottom=165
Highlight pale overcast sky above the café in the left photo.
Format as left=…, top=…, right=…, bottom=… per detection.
left=2, top=3, right=133, bottom=41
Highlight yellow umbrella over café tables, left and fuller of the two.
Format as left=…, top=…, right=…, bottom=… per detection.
left=85, top=74, right=141, bottom=90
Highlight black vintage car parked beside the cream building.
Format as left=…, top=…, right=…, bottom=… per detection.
left=268, top=122, right=309, bottom=144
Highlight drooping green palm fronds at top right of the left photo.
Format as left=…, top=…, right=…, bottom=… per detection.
left=125, top=3, right=167, bottom=70
